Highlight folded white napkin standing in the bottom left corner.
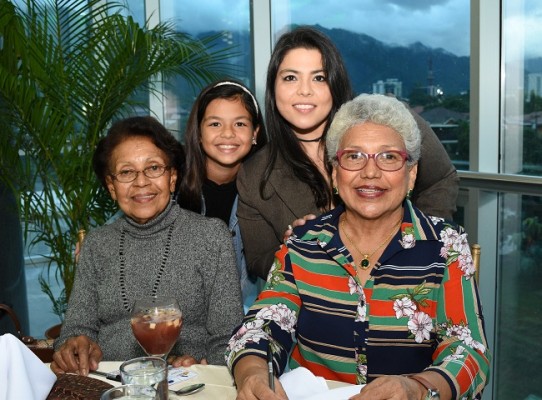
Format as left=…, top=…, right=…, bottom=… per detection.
left=0, top=333, right=56, bottom=400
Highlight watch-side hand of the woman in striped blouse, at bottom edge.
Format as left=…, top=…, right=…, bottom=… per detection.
left=349, top=375, right=425, bottom=400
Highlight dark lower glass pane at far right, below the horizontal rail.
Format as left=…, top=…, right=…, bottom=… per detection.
left=498, top=194, right=542, bottom=399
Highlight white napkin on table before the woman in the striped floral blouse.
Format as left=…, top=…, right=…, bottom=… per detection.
left=279, top=367, right=363, bottom=400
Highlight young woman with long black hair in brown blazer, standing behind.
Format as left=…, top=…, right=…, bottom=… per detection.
left=237, top=27, right=459, bottom=279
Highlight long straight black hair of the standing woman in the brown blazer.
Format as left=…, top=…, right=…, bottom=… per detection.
left=260, top=26, right=353, bottom=209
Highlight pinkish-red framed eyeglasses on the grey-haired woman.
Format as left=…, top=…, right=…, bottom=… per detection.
left=335, top=150, right=408, bottom=172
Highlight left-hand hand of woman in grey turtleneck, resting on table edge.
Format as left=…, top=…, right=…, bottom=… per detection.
left=51, top=335, right=103, bottom=376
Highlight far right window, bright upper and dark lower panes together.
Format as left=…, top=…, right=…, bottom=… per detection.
left=496, top=0, right=542, bottom=399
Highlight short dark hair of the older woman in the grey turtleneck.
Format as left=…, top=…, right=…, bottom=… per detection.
left=92, top=116, right=185, bottom=189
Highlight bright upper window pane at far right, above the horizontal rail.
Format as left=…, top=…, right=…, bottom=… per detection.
left=502, top=0, right=542, bottom=176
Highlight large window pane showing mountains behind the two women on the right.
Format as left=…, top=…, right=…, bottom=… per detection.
left=271, top=0, right=470, bottom=169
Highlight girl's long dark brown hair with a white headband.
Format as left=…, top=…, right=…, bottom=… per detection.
left=177, top=79, right=267, bottom=213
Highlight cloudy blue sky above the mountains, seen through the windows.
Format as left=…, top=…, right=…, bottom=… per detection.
left=161, top=0, right=542, bottom=56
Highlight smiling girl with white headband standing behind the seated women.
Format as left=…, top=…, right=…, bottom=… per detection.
left=178, top=80, right=267, bottom=311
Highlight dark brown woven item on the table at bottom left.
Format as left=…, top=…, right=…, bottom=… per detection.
left=47, top=374, right=113, bottom=400
